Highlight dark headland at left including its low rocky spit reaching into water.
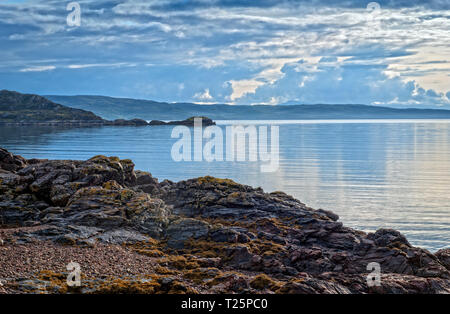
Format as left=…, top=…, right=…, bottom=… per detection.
left=0, top=90, right=215, bottom=127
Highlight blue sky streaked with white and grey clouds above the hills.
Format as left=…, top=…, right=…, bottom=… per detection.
left=0, top=0, right=450, bottom=109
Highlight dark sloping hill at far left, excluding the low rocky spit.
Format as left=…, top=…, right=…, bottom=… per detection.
left=0, top=90, right=103, bottom=124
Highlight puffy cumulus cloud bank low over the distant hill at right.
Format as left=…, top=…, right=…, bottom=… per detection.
left=238, top=58, right=450, bottom=107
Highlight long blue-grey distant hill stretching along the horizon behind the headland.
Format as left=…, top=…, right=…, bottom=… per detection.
left=46, top=96, right=450, bottom=120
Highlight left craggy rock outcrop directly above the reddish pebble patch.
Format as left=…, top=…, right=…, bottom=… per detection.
left=0, top=152, right=168, bottom=242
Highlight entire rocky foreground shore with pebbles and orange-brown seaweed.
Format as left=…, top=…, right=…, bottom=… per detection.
left=0, top=149, right=450, bottom=294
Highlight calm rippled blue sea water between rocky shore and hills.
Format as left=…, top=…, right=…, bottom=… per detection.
left=0, top=121, right=450, bottom=251
